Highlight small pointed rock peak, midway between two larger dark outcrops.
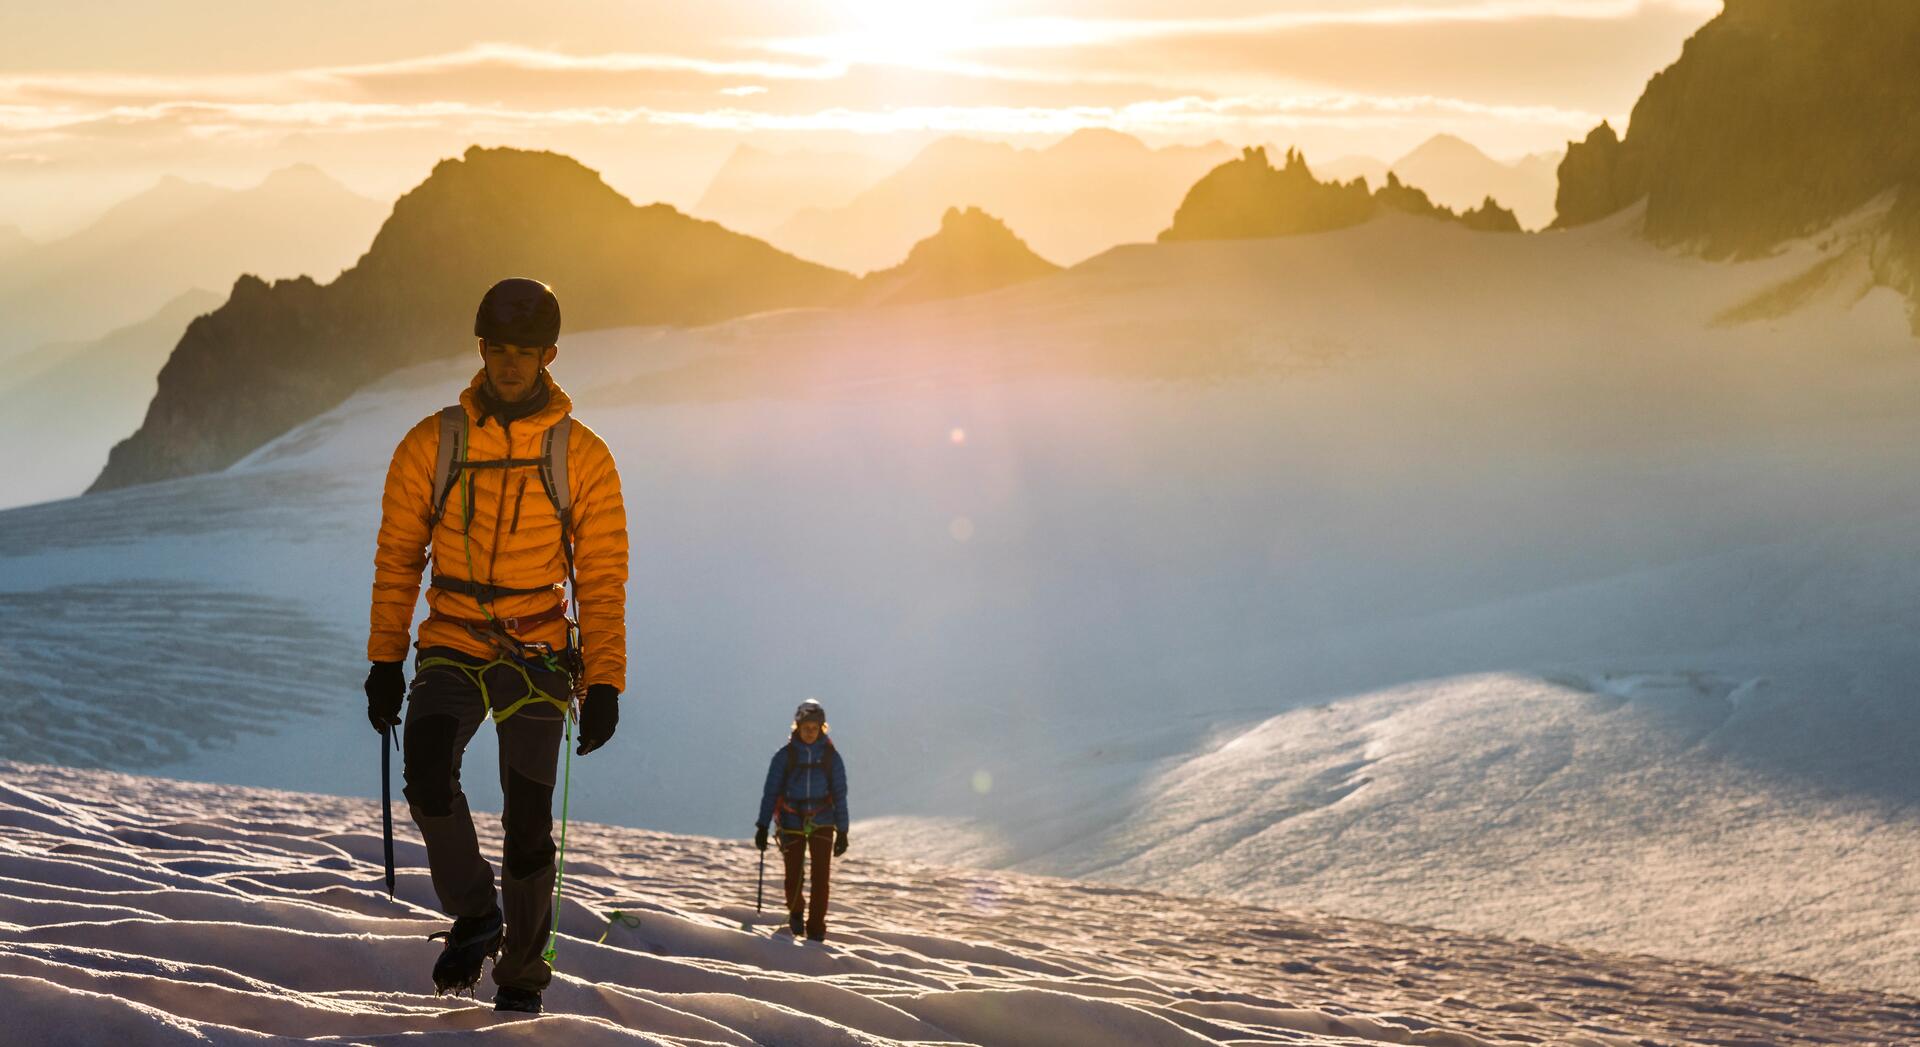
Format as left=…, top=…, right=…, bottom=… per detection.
left=856, top=207, right=1060, bottom=305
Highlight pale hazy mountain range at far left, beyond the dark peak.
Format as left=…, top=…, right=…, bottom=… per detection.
left=0, top=165, right=386, bottom=359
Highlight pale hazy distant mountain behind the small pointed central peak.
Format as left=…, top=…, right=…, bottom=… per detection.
left=768, top=129, right=1233, bottom=273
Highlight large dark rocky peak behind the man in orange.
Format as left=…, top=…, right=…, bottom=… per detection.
left=90, top=146, right=854, bottom=490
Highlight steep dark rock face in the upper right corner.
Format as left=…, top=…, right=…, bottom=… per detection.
left=1555, top=0, right=1920, bottom=257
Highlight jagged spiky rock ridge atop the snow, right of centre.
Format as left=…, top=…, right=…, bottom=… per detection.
left=1160, top=146, right=1521, bottom=242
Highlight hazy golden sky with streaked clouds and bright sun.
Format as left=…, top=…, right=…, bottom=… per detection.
left=0, top=0, right=1720, bottom=238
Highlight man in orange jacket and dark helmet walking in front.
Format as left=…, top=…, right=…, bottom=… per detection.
left=367, top=279, right=628, bottom=1014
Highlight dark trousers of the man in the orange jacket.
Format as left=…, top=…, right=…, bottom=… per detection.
left=403, top=647, right=570, bottom=991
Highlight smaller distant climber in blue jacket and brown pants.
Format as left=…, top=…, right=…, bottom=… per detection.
left=753, top=697, right=847, bottom=941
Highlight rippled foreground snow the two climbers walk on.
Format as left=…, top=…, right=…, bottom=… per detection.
left=0, top=763, right=1920, bottom=1047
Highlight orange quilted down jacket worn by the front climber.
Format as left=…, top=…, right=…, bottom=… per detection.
left=367, top=369, right=626, bottom=692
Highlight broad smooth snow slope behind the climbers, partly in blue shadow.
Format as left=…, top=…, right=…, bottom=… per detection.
left=0, top=215, right=1920, bottom=989
